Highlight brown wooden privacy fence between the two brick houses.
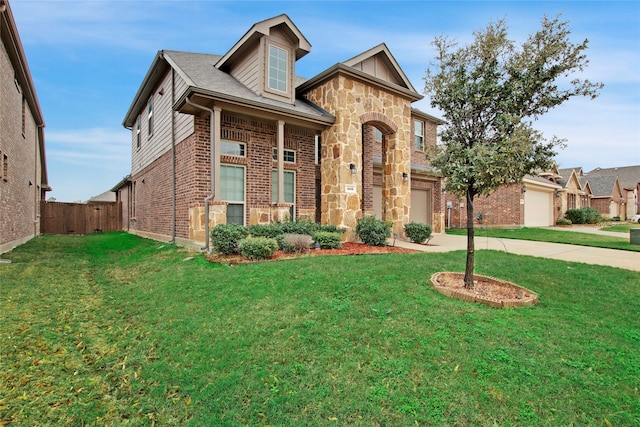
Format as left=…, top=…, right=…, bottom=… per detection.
left=40, top=201, right=122, bottom=234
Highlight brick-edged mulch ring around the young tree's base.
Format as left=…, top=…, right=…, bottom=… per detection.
left=431, top=272, right=538, bottom=308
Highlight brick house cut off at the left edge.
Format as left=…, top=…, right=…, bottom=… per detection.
left=0, top=0, right=51, bottom=253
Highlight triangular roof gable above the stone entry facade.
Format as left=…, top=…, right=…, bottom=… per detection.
left=343, top=43, right=416, bottom=92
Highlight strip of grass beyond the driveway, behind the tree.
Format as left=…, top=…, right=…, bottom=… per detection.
left=447, top=227, right=640, bottom=252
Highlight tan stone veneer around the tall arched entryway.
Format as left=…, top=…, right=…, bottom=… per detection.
left=305, top=75, right=412, bottom=240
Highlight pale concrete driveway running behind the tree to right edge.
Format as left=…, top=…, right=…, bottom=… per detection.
left=395, top=229, right=640, bottom=271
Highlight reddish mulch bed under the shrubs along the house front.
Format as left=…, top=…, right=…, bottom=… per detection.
left=205, top=242, right=420, bottom=264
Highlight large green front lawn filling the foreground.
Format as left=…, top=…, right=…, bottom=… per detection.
left=0, top=233, right=640, bottom=426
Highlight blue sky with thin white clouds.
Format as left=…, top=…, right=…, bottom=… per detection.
left=10, top=0, right=640, bottom=202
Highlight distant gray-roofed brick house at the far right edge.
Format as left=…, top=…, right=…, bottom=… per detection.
left=584, top=165, right=640, bottom=220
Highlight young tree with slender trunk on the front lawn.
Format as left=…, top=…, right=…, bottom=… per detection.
left=425, top=16, right=603, bottom=289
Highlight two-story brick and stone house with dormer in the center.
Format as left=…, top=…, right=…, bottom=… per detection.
left=113, top=15, right=444, bottom=246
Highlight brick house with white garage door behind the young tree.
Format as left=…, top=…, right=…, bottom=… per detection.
left=445, top=174, right=561, bottom=228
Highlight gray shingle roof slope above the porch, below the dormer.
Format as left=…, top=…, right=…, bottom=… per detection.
left=164, top=50, right=335, bottom=122
